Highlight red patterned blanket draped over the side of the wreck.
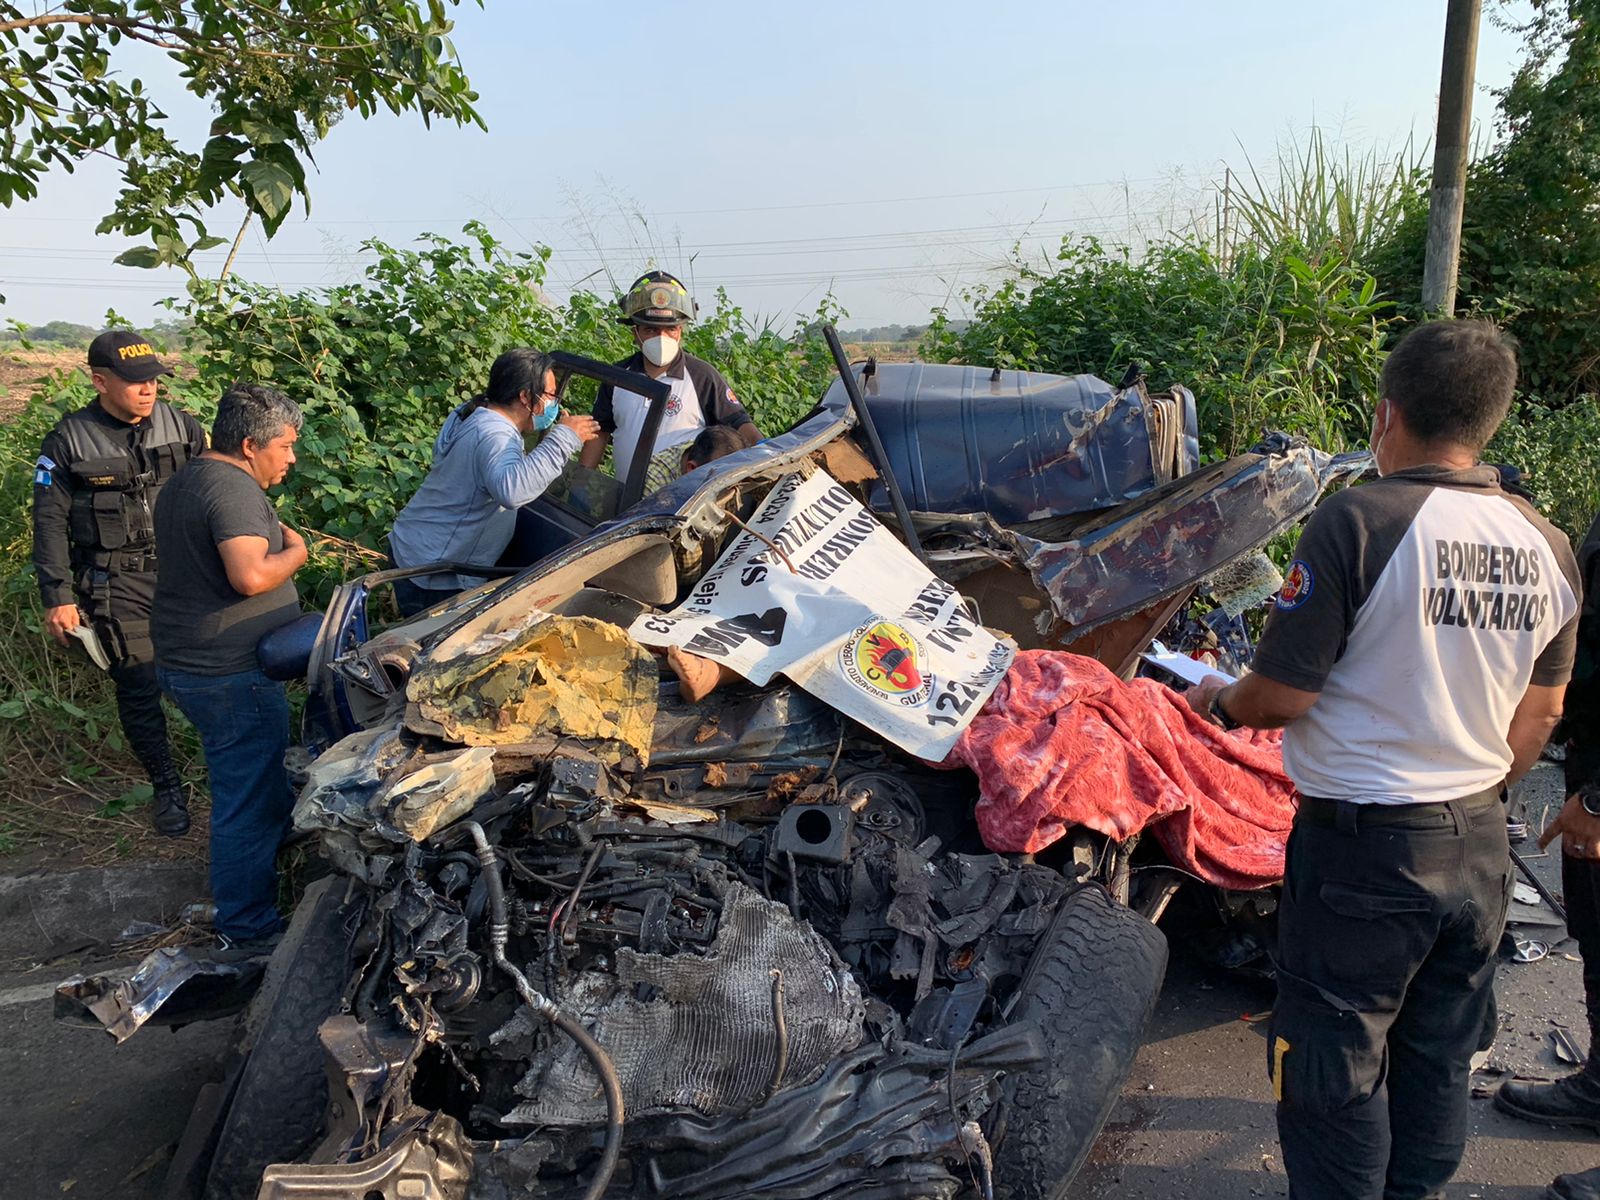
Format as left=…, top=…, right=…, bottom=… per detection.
left=944, top=650, right=1294, bottom=890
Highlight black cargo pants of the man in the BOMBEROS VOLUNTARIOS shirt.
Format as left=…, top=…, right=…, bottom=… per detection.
left=1267, top=787, right=1512, bottom=1200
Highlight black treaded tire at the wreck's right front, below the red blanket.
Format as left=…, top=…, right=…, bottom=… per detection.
left=995, top=885, right=1166, bottom=1200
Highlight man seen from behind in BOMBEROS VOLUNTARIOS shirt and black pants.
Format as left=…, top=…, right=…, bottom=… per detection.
left=1189, top=322, right=1579, bottom=1200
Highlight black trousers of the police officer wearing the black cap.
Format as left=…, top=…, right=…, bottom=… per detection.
left=78, top=570, right=171, bottom=778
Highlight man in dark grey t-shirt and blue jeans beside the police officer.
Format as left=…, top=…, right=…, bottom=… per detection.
left=150, top=384, right=306, bottom=957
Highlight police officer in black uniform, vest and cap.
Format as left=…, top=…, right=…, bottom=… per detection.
left=34, top=330, right=206, bottom=837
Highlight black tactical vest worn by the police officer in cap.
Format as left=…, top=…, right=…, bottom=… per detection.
left=61, top=403, right=189, bottom=595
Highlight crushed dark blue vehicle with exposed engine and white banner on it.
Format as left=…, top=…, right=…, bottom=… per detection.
left=62, top=339, right=1346, bottom=1200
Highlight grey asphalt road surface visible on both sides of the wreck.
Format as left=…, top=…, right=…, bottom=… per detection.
left=0, top=766, right=1600, bottom=1200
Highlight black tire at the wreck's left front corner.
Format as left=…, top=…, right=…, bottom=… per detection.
left=205, top=878, right=350, bottom=1200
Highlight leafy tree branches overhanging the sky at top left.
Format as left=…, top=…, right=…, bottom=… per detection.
left=0, top=0, right=483, bottom=270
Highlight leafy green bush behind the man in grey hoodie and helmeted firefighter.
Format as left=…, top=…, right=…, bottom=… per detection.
left=184, top=224, right=834, bottom=569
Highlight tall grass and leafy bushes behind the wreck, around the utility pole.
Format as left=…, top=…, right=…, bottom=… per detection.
left=922, top=131, right=1600, bottom=538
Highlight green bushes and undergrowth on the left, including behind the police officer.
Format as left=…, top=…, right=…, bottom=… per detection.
left=0, top=224, right=843, bottom=846
